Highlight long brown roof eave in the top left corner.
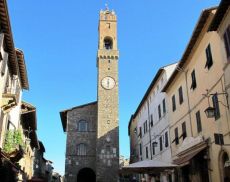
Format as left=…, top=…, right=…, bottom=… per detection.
left=0, top=0, right=18, bottom=75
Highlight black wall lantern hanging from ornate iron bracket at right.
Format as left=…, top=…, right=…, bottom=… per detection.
left=202, top=90, right=229, bottom=118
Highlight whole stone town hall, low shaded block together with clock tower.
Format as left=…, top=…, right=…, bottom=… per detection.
left=60, top=8, right=119, bottom=182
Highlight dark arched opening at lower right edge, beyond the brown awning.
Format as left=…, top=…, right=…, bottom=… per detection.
left=220, top=151, right=230, bottom=182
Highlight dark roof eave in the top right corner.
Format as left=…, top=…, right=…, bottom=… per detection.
left=208, top=0, right=230, bottom=31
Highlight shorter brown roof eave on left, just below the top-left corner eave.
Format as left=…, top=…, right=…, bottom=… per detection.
left=16, top=49, right=29, bottom=90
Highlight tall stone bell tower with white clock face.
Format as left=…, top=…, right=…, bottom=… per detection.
left=96, top=7, right=119, bottom=182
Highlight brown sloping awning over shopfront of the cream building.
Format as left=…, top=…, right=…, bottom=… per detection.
left=173, top=144, right=207, bottom=166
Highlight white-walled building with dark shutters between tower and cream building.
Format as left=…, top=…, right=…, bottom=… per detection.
left=129, top=63, right=177, bottom=181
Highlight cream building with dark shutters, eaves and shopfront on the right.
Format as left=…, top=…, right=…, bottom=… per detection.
left=163, top=1, right=230, bottom=182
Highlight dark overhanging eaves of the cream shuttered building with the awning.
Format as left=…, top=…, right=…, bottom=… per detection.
left=162, top=7, right=217, bottom=92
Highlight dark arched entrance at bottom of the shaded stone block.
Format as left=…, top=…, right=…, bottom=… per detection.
left=77, top=168, right=96, bottom=182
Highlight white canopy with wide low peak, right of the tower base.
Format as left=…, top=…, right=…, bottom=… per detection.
left=121, top=159, right=177, bottom=174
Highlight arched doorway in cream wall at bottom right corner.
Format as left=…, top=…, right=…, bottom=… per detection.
left=219, top=150, right=230, bottom=182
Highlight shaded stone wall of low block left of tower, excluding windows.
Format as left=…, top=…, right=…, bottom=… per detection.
left=65, top=102, right=97, bottom=182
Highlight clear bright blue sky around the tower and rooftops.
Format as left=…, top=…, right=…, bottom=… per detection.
left=8, top=0, right=219, bottom=174
